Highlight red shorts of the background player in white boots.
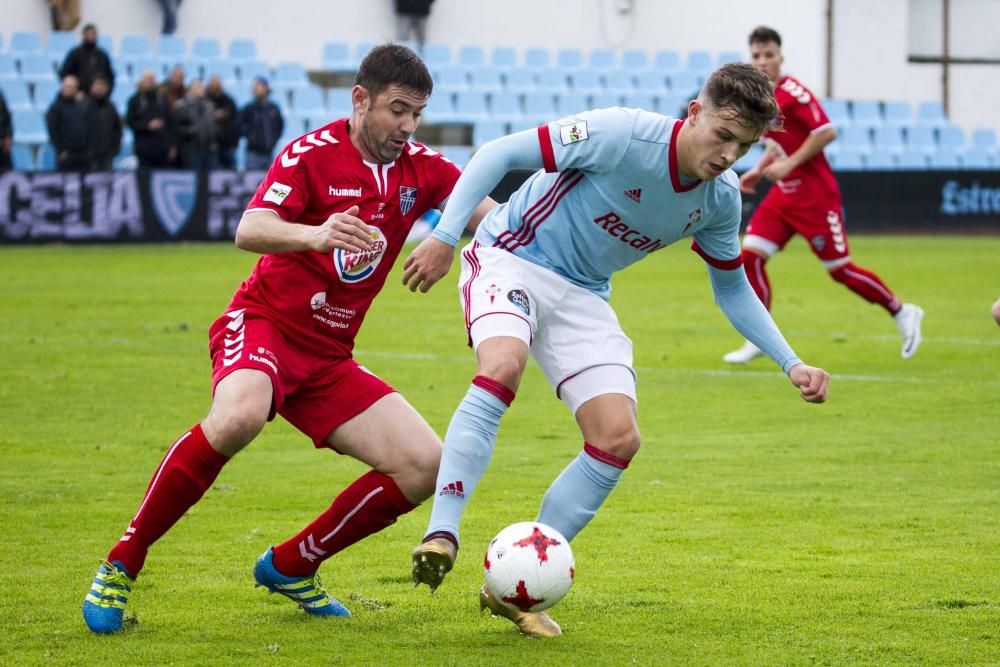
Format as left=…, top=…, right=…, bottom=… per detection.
left=746, top=186, right=851, bottom=263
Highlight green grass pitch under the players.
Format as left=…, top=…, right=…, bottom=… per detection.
left=0, top=236, right=1000, bottom=665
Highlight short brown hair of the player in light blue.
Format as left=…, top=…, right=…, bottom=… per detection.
left=700, top=63, right=779, bottom=131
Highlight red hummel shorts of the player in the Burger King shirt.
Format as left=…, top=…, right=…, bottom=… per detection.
left=208, top=311, right=395, bottom=447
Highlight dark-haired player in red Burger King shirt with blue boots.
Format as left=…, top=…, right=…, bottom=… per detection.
left=83, top=44, right=495, bottom=633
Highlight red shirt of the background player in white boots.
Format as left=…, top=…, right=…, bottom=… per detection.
left=764, top=76, right=840, bottom=202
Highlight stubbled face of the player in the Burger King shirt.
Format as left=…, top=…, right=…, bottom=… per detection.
left=354, top=84, right=427, bottom=163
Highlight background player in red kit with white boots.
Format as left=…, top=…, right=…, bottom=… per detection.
left=723, top=26, right=924, bottom=364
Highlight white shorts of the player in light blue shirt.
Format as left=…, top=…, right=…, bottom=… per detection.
left=458, top=241, right=636, bottom=414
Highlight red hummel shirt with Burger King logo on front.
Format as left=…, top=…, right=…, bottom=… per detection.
left=229, top=119, right=459, bottom=358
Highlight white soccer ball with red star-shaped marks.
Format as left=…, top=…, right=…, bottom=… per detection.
left=483, top=521, right=574, bottom=612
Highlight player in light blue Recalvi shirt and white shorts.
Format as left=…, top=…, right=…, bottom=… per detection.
left=403, top=64, right=829, bottom=636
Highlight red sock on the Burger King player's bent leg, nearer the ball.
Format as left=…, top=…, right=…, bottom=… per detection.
left=274, top=470, right=416, bottom=577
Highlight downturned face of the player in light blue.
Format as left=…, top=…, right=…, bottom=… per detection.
left=677, top=100, right=763, bottom=181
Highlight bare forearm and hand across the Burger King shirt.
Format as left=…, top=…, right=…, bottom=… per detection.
left=236, top=206, right=371, bottom=254
